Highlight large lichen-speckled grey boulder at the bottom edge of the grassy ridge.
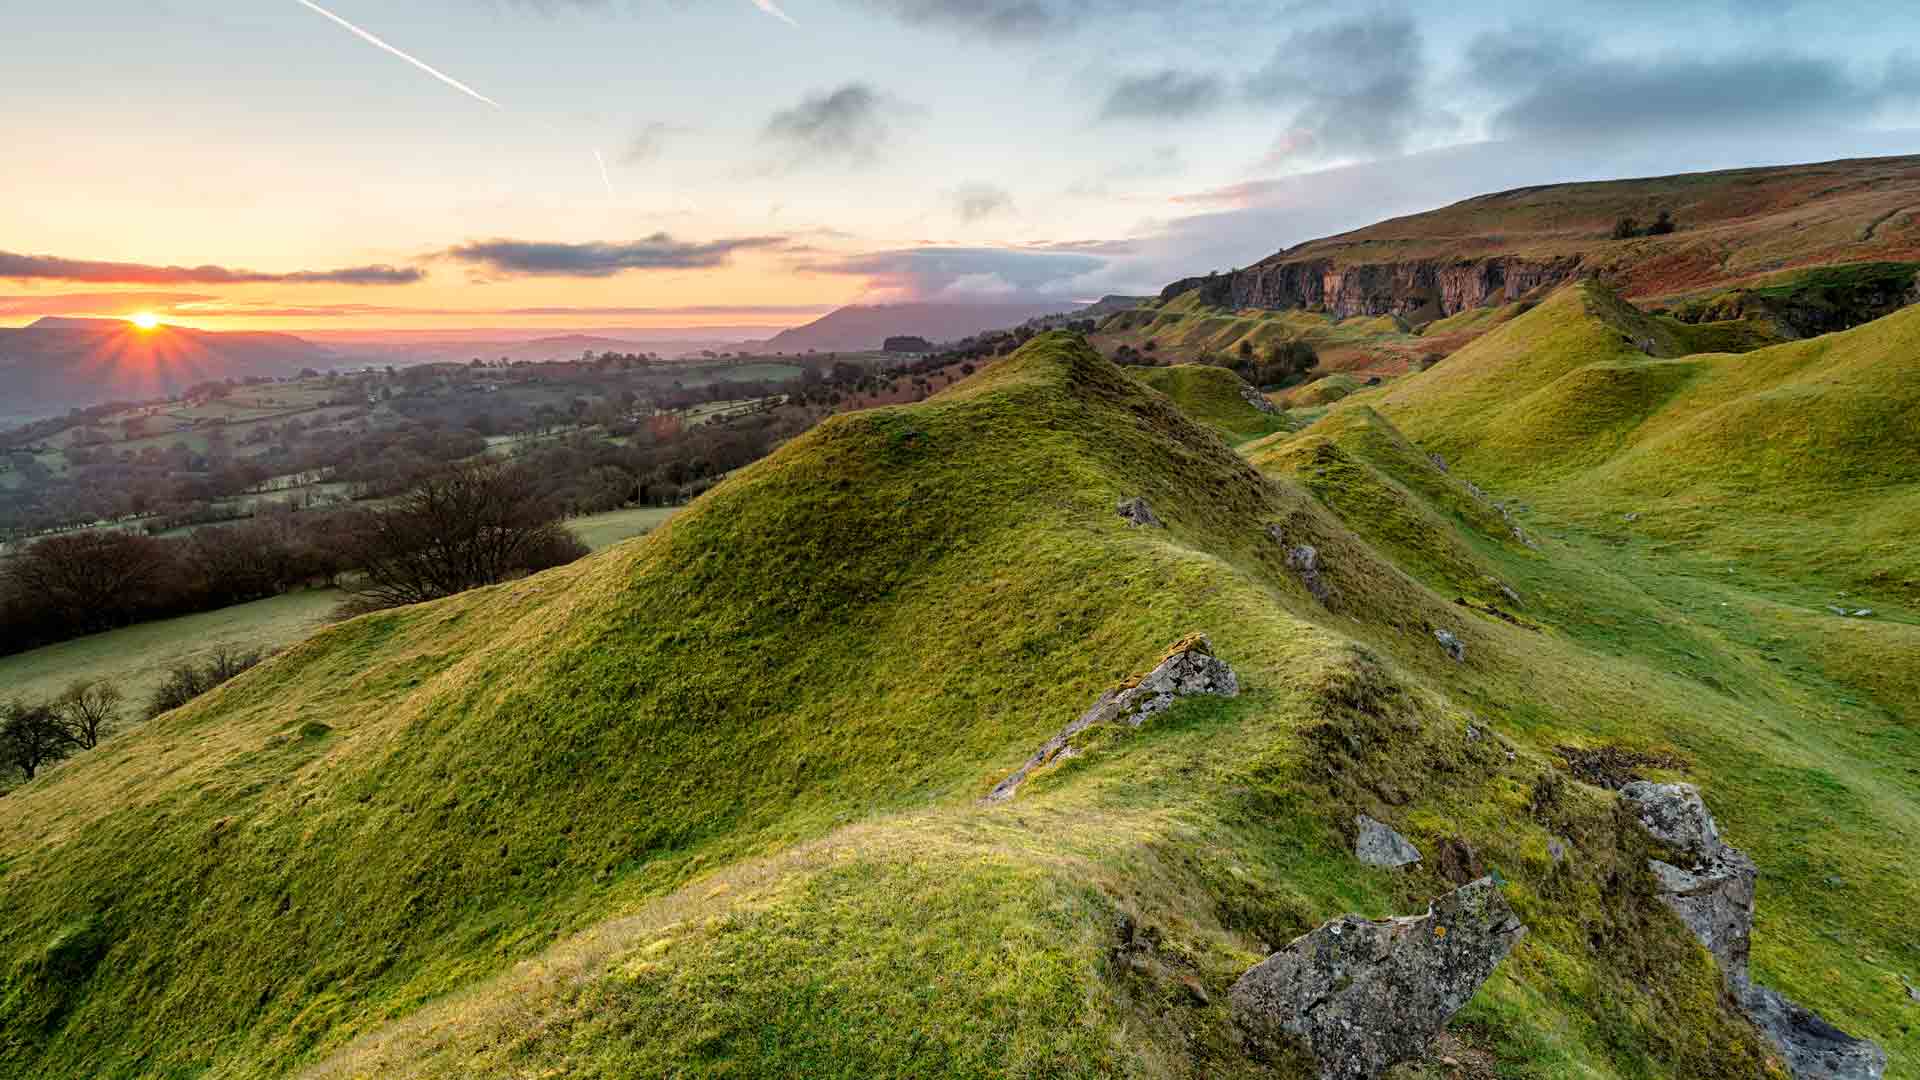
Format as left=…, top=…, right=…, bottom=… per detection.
left=1233, top=878, right=1526, bottom=1080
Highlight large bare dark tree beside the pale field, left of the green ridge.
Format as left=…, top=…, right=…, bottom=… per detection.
left=334, top=465, right=586, bottom=609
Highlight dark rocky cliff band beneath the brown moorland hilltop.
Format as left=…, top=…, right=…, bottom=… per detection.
left=1160, top=256, right=1584, bottom=319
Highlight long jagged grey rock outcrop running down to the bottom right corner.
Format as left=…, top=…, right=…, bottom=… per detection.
left=1620, top=780, right=1887, bottom=1080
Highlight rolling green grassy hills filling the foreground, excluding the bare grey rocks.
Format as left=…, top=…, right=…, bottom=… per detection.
left=0, top=319, right=1920, bottom=1078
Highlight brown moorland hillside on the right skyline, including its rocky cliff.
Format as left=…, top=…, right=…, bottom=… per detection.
left=1164, top=156, right=1920, bottom=319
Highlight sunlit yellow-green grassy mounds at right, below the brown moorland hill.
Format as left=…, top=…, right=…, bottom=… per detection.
left=1377, top=278, right=1920, bottom=603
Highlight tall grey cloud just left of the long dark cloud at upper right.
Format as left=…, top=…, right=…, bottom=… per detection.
left=1244, top=13, right=1444, bottom=163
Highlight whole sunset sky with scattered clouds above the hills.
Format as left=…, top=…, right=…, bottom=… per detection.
left=0, top=0, right=1920, bottom=331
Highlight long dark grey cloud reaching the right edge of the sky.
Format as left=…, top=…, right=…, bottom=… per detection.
left=1467, top=29, right=1916, bottom=138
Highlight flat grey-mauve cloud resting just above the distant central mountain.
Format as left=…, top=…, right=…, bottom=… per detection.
left=797, top=248, right=1106, bottom=300
